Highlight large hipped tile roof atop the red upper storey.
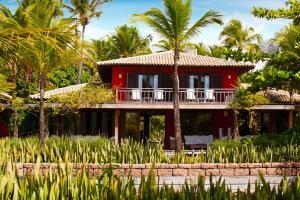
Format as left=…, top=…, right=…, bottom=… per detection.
left=97, top=51, right=254, bottom=68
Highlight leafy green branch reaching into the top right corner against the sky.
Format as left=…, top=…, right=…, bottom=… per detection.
left=252, top=0, right=300, bottom=24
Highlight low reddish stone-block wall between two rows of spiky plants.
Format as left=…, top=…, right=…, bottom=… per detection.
left=12, top=162, right=300, bottom=176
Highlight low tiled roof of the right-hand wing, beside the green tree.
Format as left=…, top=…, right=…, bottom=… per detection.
left=259, top=89, right=300, bottom=104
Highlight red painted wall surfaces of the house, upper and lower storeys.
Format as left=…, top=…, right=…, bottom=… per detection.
left=108, top=66, right=245, bottom=146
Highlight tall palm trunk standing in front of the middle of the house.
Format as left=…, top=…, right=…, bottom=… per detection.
left=173, top=42, right=183, bottom=151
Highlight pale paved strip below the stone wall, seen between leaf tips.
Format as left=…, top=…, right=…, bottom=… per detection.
left=133, top=176, right=296, bottom=191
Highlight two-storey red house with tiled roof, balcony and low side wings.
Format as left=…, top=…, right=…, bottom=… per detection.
left=32, top=51, right=300, bottom=148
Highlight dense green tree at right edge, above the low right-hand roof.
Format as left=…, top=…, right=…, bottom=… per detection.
left=259, top=24, right=300, bottom=102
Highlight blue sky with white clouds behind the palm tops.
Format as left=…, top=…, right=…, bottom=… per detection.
left=0, top=0, right=289, bottom=48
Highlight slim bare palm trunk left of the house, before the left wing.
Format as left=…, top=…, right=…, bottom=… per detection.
left=40, top=75, right=46, bottom=147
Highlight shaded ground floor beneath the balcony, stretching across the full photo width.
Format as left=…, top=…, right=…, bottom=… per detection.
left=0, top=103, right=300, bottom=149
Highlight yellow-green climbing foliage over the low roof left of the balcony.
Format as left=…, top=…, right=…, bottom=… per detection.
left=48, top=83, right=115, bottom=110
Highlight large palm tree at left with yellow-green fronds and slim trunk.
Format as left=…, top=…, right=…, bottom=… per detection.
left=0, top=0, right=79, bottom=145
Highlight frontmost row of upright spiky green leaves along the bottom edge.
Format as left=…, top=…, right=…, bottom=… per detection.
left=0, top=163, right=300, bottom=200
